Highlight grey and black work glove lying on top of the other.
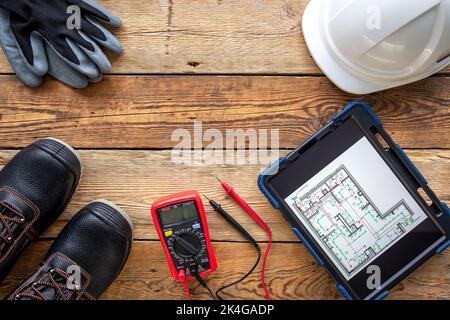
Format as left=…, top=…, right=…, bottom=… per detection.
left=0, top=0, right=123, bottom=78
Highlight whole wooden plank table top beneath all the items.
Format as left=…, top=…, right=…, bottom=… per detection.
left=0, top=0, right=450, bottom=299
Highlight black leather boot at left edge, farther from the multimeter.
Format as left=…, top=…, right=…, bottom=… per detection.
left=0, top=138, right=81, bottom=282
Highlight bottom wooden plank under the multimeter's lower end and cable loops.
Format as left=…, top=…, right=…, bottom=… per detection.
left=0, top=241, right=450, bottom=300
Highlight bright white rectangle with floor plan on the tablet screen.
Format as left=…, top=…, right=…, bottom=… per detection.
left=285, top=137, right=427, bottom=280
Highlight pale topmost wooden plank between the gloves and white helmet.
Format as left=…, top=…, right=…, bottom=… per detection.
left=0, top=0, right=450, bottom=74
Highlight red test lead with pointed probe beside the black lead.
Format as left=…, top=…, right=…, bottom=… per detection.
left=216, top=177, right=272, bottom=300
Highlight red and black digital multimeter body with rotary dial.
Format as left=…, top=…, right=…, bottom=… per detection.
left=151, top=191, right=217, bottom=280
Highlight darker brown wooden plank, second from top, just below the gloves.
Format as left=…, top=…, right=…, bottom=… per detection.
left=0, top=76, right=450, bottom=149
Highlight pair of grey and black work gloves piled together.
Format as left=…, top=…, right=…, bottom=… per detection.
left=0, top=0, right=123, bottom=88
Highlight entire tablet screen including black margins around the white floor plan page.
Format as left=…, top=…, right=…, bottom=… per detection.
left=268, top=118, right=445, bottom=299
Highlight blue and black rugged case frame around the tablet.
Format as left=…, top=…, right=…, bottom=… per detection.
left=258, top=100, right=450, bottom=300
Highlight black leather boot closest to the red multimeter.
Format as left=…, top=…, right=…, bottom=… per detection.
left=8, top=200, right=133, bottom=300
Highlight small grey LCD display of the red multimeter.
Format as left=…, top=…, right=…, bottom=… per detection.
left=158, top=200, right=199, bottom=227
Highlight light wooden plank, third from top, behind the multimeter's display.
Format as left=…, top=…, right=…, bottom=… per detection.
left=0, top=150, right=450, bottom=241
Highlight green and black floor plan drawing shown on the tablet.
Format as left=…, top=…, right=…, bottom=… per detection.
left=293, top=166, right=420, bottom=276
